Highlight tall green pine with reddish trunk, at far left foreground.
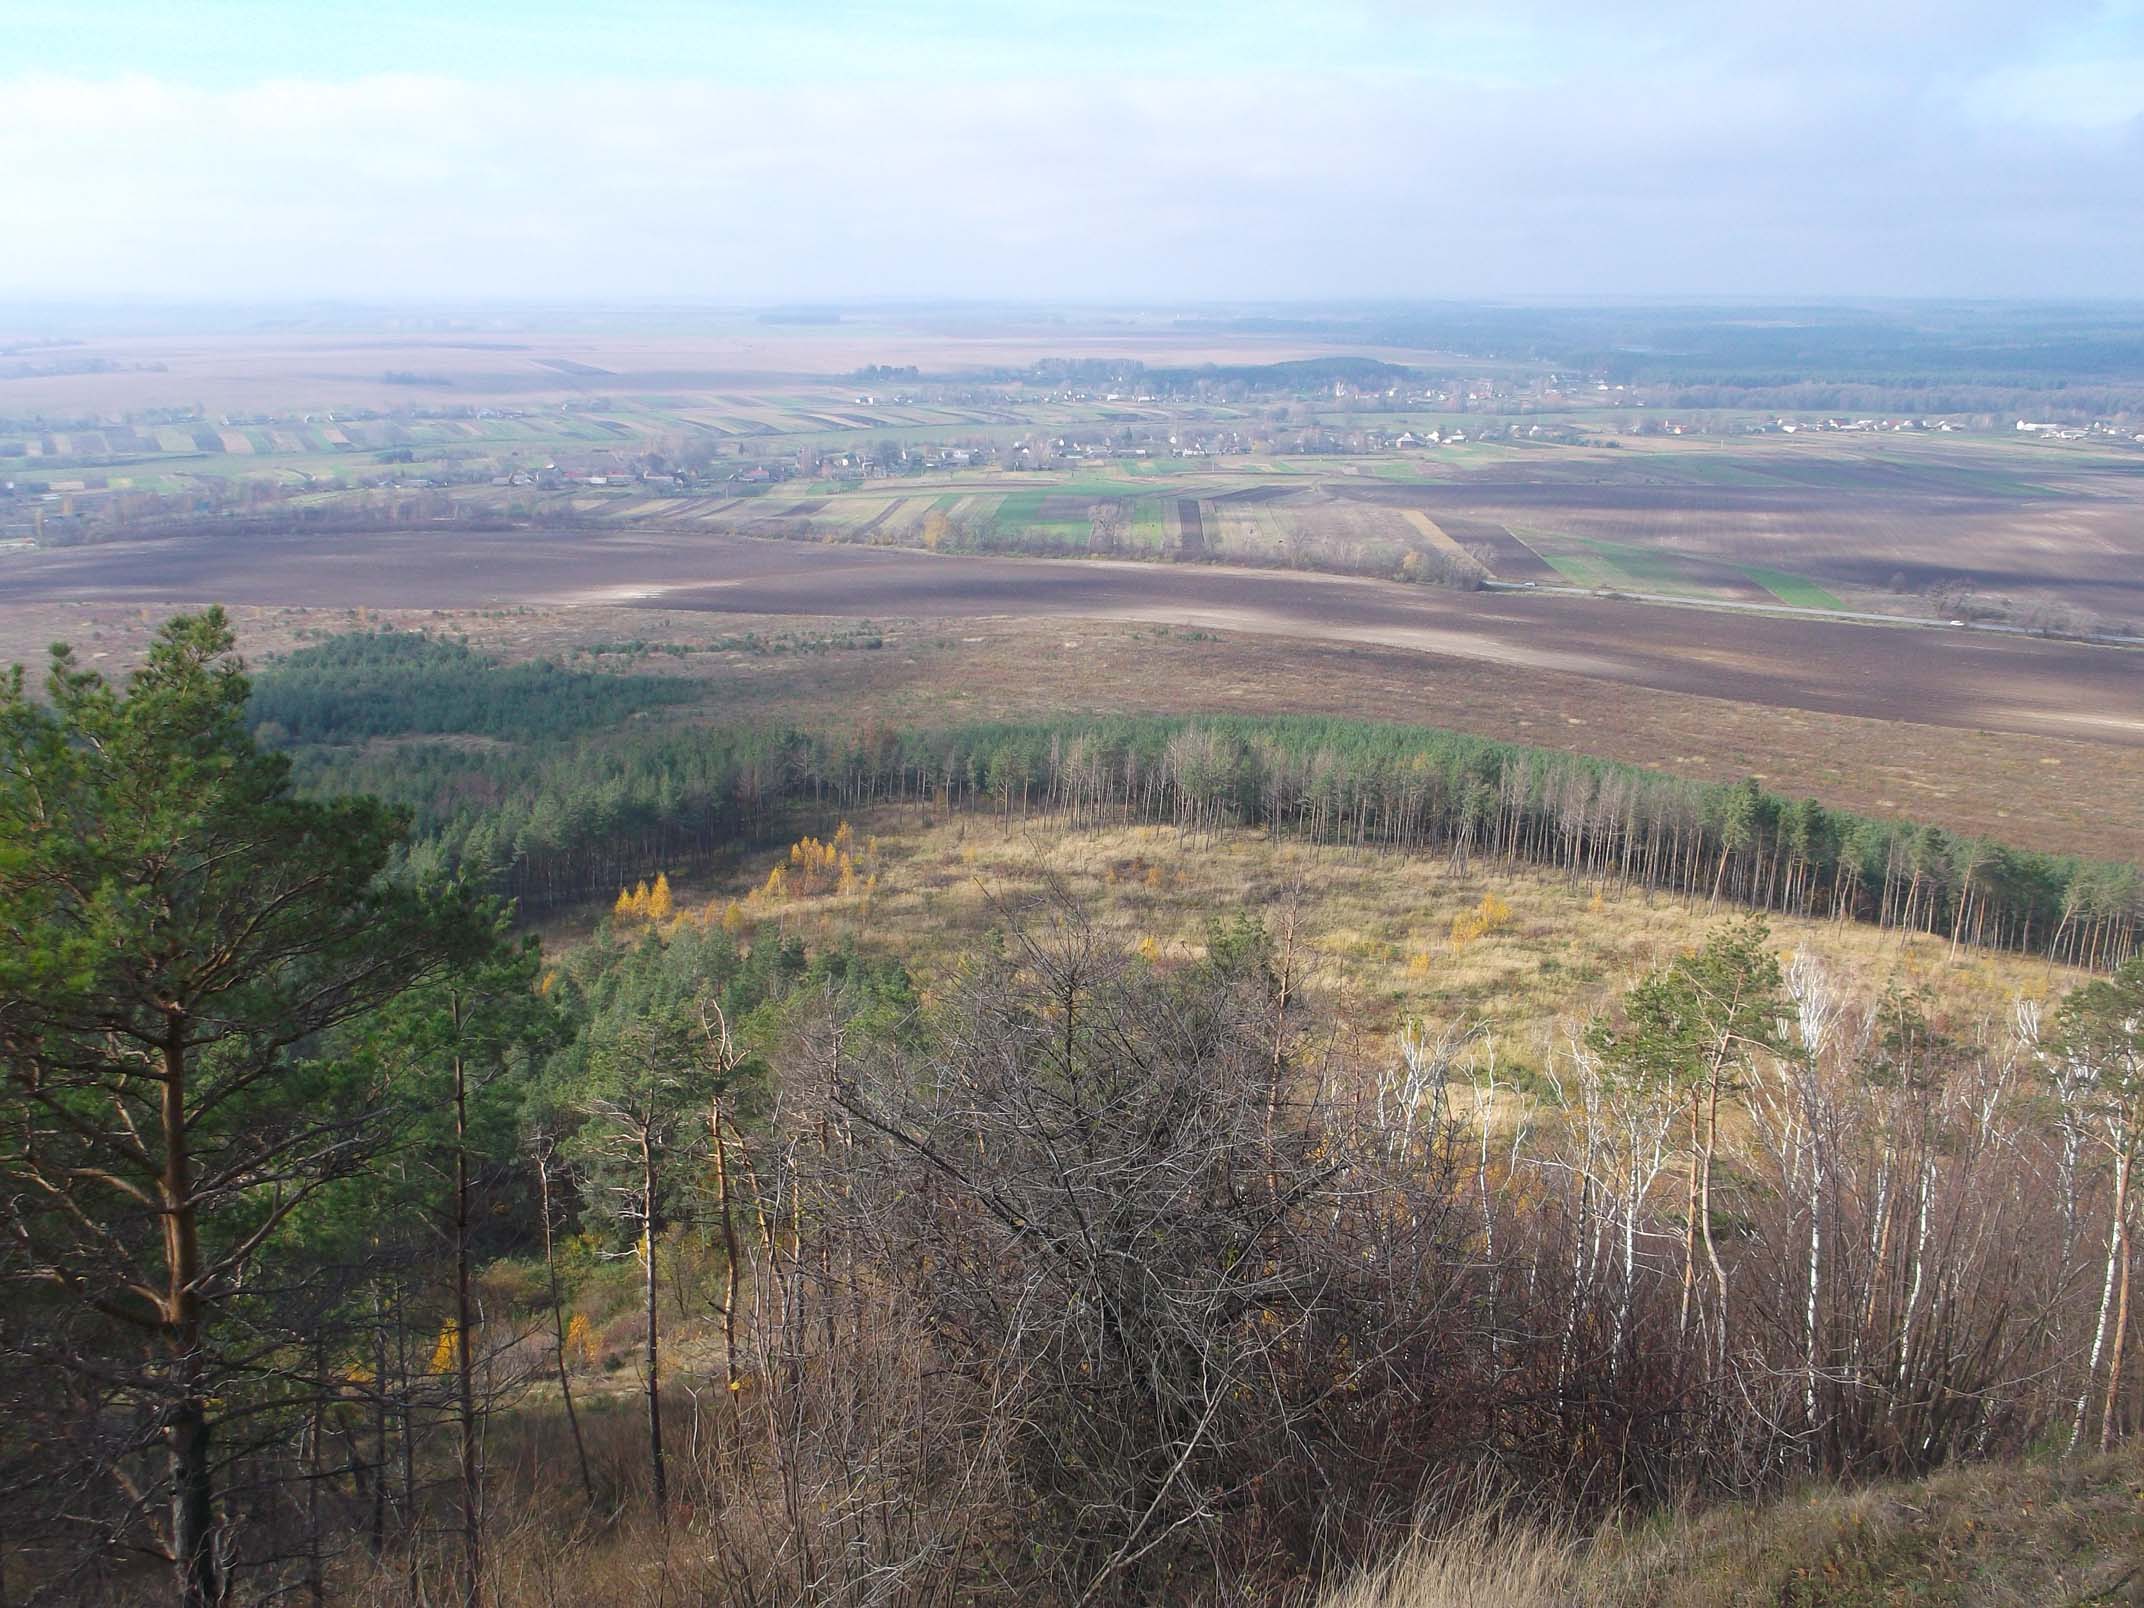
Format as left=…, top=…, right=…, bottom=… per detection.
left=0, top=609, right=491, bottom=1608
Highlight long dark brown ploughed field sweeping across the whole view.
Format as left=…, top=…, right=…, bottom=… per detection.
left=0, top=527, right=2144, bottom=746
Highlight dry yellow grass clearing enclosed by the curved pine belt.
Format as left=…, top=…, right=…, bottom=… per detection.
left=656, top=813, right=2075, bottom=1066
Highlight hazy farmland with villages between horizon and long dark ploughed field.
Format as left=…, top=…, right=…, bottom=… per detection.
left=16, top=317, right=2144, bottom=632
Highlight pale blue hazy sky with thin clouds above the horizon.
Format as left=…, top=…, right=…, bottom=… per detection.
left=0, top=0, right=2144, bottom=302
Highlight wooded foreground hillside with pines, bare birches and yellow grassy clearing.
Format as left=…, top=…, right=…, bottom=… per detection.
left=0, top=613, right=2144, bottom=1608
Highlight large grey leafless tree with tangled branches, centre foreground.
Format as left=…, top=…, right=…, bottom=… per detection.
left=836, top=905, right=1466, bottom=1602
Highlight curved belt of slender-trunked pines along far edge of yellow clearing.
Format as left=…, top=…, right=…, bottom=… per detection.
left=280, top=716, right=2144, bottom=967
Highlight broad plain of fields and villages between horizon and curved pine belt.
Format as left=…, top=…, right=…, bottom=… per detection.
left=0, top=313, right=2144, bottom=887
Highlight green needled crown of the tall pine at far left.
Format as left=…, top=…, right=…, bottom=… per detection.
left=0, top=611, right=489, bottom=1301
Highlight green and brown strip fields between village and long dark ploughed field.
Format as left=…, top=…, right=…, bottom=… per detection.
left=398, top=443, right=2144, bottom=632
